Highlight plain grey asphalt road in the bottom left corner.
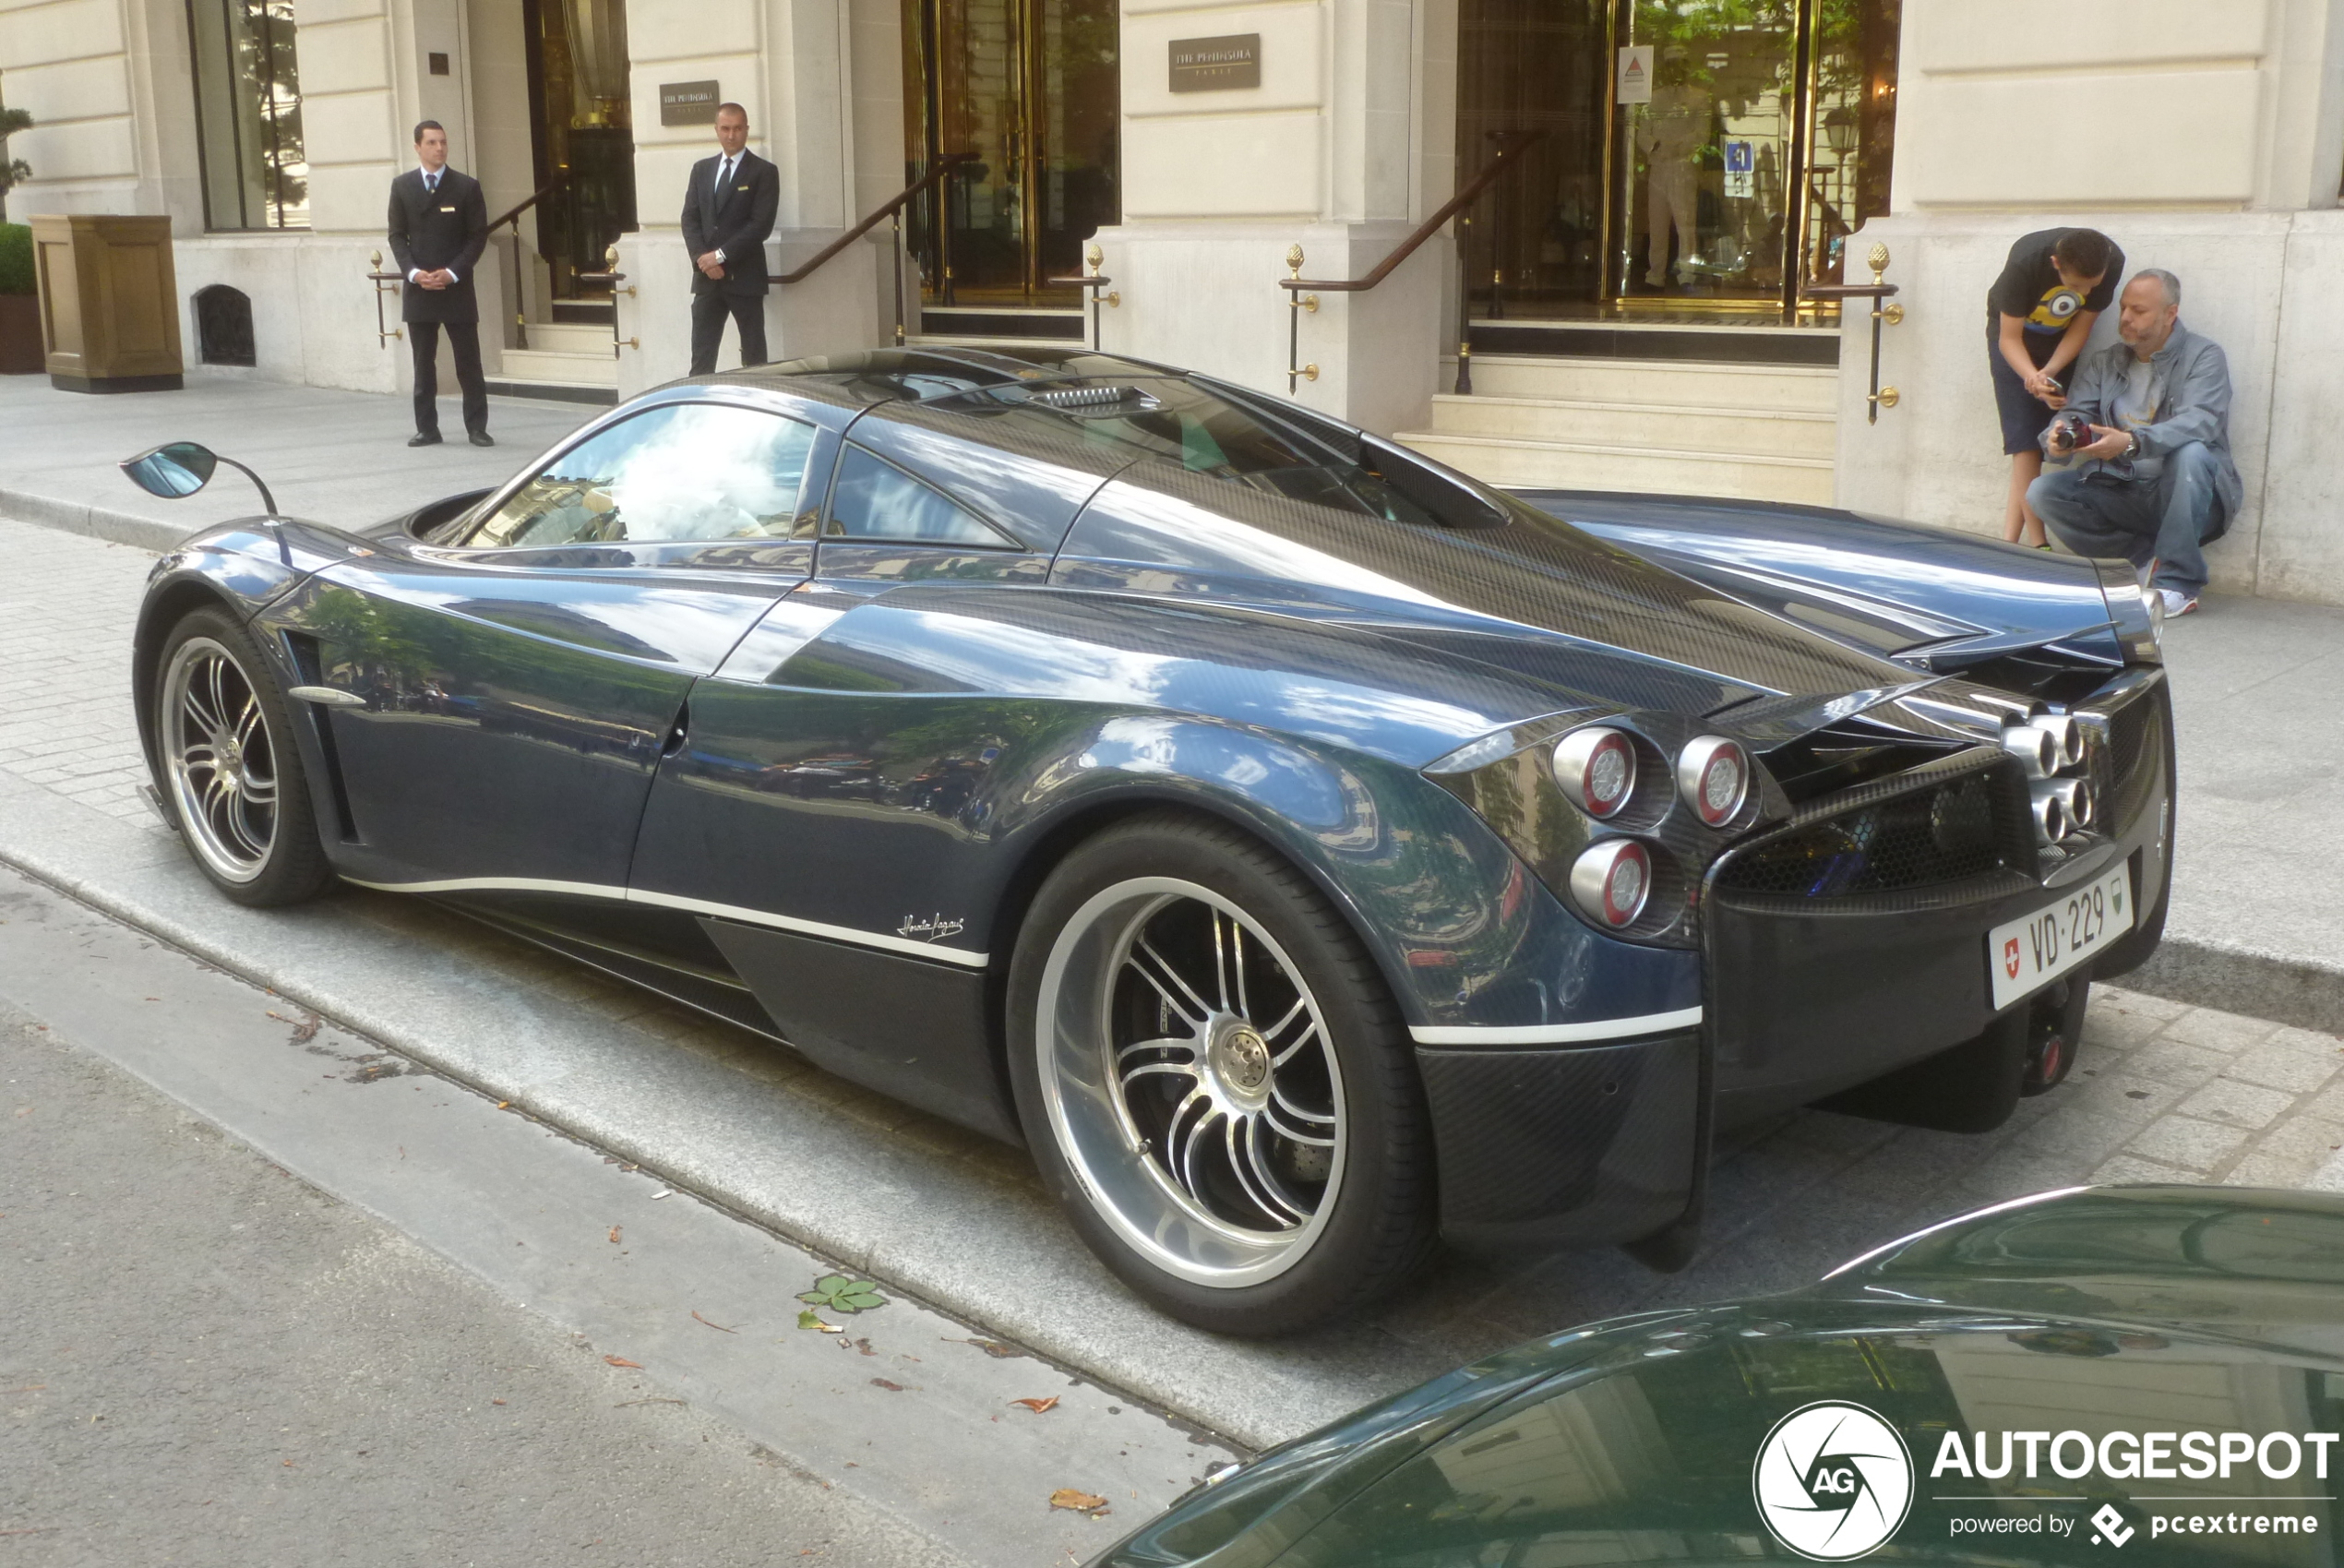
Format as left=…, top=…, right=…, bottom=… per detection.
left=0, top=1008, right=963, bottom=1568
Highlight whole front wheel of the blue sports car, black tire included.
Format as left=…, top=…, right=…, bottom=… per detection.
left=152, top=609, right=333, bottom=909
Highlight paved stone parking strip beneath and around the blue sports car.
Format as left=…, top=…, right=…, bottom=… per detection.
left=0, top=522, right=2344, bottom=1446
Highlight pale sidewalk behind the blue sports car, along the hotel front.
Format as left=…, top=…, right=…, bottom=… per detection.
left=0, top=370, right=2344, bottom=1029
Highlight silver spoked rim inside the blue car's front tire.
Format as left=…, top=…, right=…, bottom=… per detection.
left=157, top=638, right=277, bottom=881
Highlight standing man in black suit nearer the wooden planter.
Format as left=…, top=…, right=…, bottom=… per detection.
left=391, top=120, right=496, bottom=446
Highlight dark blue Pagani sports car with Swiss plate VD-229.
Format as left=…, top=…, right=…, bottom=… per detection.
left=136, top=352, right=2173, bottom=1334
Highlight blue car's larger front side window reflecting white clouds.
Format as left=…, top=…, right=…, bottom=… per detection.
left=464, top=403, right=813, bottom=548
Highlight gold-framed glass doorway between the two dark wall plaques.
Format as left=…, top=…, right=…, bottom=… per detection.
left=904, top=0, right=1120, bottom=312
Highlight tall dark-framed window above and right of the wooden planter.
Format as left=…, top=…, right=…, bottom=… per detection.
left=187, top=0, right=309, bottom=230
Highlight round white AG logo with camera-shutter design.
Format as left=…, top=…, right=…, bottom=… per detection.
left=1751, top=1399, right=1913, bottom=1563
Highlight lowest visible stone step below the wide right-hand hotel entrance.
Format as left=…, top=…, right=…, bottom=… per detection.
left=1394, top=431, right=1833, bottom=507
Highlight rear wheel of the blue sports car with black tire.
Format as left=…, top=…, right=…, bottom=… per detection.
left=1008, top=813, right=1437, bottom=1336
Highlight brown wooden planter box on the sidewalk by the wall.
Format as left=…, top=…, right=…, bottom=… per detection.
left=33, top=213, right=185, bottom=391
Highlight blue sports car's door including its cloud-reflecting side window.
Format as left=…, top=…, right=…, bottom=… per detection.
left=281, top=399, right=834, bottom=895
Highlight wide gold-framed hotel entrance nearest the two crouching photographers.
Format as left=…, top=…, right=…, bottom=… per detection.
left=1458, top=0, right=1901, bottom=326
